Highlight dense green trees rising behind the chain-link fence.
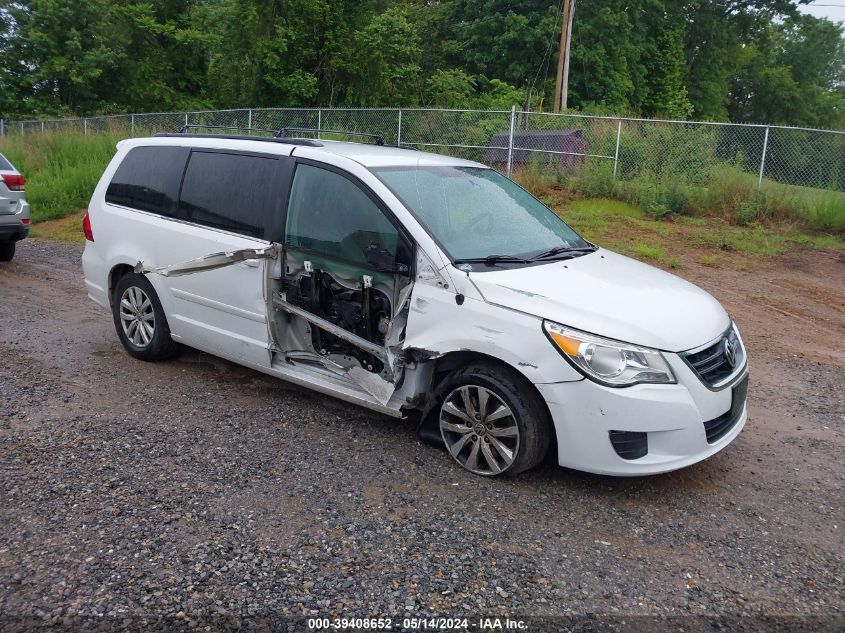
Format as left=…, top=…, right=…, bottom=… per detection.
left=0, top=0, right=845, bottom=127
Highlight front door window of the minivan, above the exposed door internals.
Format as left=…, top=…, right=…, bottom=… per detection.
left=285, top=165, right=399, bottom=264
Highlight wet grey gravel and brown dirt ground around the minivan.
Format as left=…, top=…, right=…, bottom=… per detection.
left=0, top=240, right=845, bottom=630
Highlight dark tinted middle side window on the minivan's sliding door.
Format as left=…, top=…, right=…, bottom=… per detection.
left=179, top=152, right=278, bottom=238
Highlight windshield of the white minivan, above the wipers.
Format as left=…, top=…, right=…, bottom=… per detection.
left=372, top=166, right=590, bottom=261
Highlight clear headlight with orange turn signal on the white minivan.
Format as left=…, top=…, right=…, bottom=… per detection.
left=543, top=321, right=675, bottom=387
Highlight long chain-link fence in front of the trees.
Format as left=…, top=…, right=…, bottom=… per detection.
left=0, top=108, right=845, bottom=192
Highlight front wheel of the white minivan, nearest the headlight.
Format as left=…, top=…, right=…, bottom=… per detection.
left=436, top=363, right=553, bottom=477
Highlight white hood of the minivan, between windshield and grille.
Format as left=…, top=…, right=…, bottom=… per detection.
left=470, top=249, right=730, bottom=352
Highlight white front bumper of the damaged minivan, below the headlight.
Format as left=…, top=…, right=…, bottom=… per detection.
left=536, top=354, right=748, bottom=476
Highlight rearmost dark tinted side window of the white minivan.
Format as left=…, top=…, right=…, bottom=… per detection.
left=106, top=147, right=188, bottom=215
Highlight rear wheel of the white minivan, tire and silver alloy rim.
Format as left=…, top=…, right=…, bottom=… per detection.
left=112, top=273, right=179, bottom=361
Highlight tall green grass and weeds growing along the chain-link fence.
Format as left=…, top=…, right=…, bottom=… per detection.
left=0, top=133, right=845, bottom=262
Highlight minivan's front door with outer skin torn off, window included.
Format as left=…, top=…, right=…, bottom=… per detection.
left=280, top=161, right=411, bottom=381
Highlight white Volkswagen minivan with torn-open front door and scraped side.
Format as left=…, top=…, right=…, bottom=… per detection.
left=83, top=129, right=748, bottom=476
